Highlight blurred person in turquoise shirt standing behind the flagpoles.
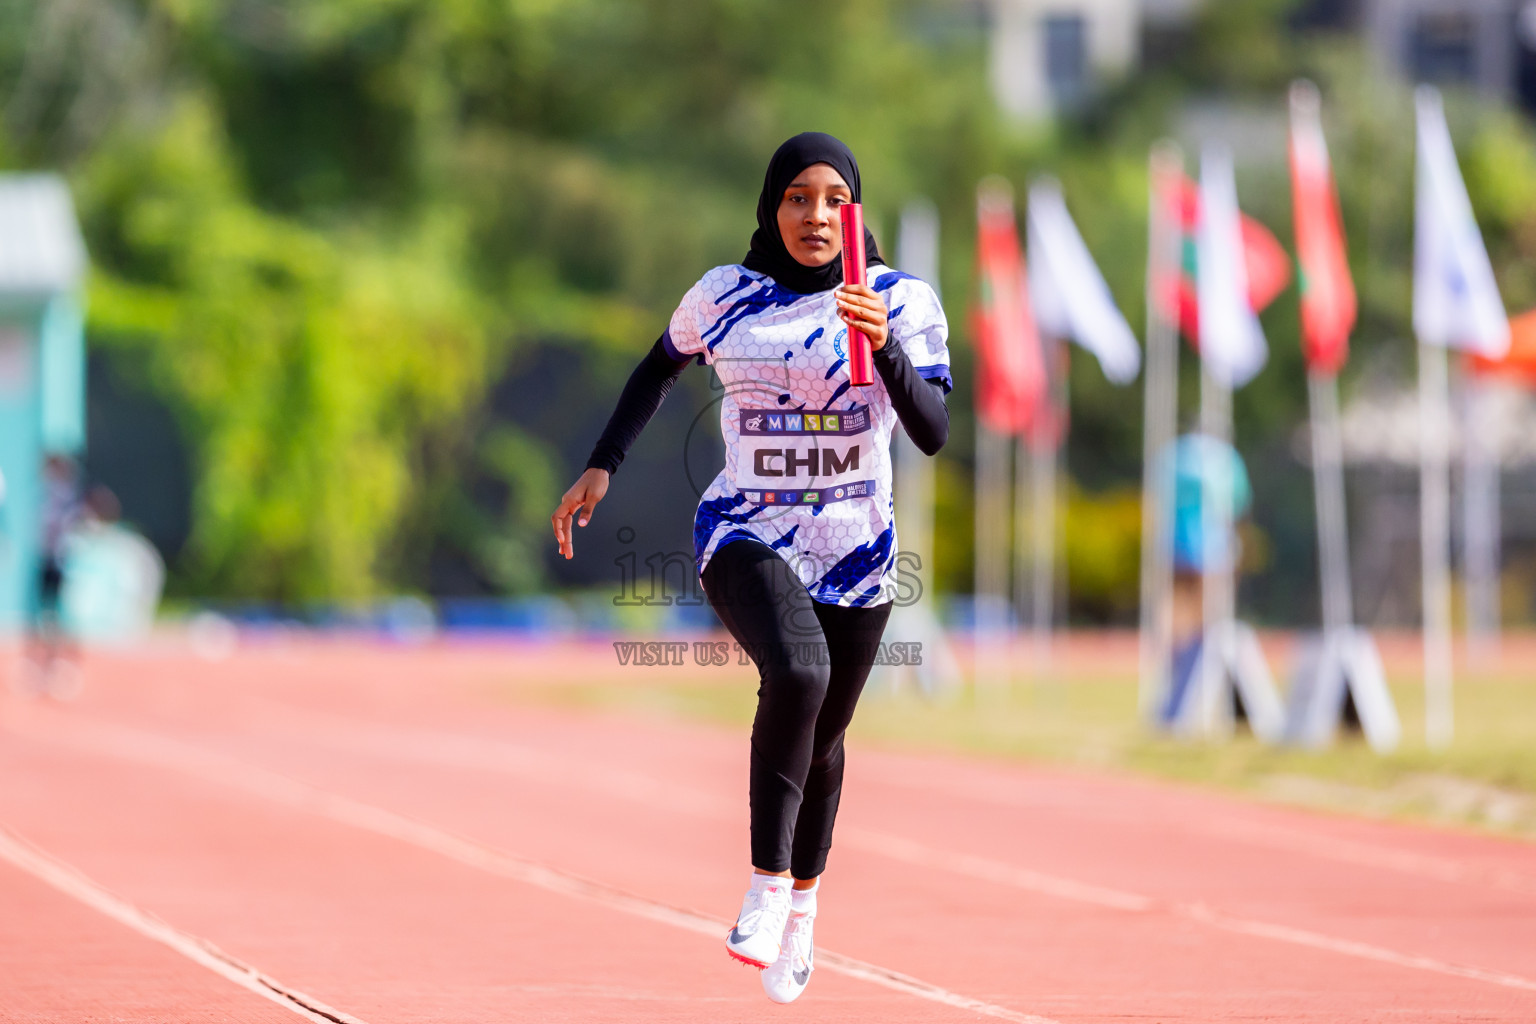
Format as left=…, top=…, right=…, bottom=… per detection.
left=1161, top=434, right=1253, bottom=723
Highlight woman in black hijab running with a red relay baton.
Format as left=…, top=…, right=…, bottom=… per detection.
left=553, top=132, right=952, bottom=1003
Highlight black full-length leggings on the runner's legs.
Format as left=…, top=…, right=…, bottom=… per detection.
left=703, top=540, right=891, bottom=878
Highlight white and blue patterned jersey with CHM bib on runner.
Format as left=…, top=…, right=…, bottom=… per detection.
left=662, top=264, right=954, bottom=606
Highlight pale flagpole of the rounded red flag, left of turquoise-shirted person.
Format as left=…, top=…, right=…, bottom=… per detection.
left=1137, top=141, right=1184, bottom=720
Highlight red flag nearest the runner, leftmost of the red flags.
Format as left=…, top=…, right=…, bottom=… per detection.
left=971, top=180, right=1048, bottom=434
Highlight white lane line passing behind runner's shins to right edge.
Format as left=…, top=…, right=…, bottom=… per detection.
left=230, top=706, right=1536, bottom=990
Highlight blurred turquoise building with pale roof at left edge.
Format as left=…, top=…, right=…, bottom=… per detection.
left=0, top=175, right=86, bottom=633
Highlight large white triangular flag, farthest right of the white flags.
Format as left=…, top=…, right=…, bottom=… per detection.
left=1413, top=86, right=1510, bottom=359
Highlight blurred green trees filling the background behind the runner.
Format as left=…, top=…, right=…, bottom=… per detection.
left=9, top=0, right=1536, bottom=617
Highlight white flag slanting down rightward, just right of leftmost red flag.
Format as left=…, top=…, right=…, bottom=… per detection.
left=1029, top=180, right=1141, bottom=384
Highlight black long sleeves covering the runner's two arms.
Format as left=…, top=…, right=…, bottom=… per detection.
left=587, top=338, right=949, bottom=473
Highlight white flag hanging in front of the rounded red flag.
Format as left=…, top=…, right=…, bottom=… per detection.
left=1195, top=146, right=1269, bottom=388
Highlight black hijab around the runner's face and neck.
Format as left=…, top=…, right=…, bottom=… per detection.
left=742, top=132, right=885, bottom=295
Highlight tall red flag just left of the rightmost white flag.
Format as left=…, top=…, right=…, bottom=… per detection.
left=1290, top=81, right=1355, bottom=375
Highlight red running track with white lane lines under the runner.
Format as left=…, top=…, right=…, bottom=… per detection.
left=0, top=643, right=1536, bottom=1024
